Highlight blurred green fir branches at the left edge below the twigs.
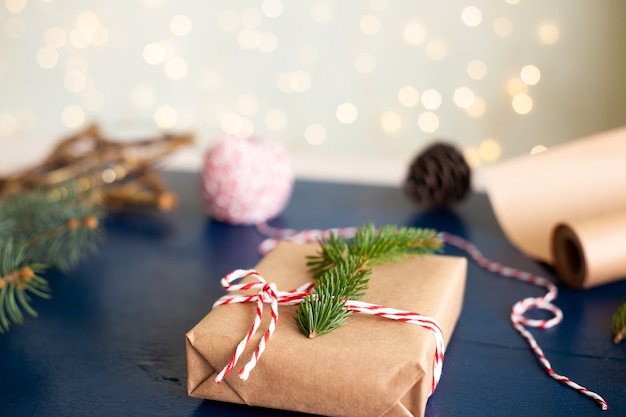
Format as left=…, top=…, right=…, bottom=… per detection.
left=0, top=181, right=103, bottom=333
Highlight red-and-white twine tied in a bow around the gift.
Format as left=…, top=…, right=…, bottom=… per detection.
left=213, top=269, right=445, bottom=394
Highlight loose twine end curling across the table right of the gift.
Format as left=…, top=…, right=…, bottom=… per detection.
left=441, top=233, right=609, bottom=410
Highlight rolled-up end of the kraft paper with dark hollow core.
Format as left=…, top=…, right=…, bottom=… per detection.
left=552, top=211, right=626, bottom=289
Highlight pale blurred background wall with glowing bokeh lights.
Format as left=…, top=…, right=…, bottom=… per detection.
left=0, top=0, right=626, bottom=183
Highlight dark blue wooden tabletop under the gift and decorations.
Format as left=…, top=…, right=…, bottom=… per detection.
left=0, top=173, right=626, bottom=417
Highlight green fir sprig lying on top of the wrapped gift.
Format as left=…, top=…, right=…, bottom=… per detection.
left=295, top=223, right=442, bottom=338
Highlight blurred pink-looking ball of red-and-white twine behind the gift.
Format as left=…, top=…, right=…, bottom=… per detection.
left=201, top=136, right=294, bottom=224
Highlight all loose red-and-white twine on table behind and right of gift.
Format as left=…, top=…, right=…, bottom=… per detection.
left=257, top=223, right=609, bottom=410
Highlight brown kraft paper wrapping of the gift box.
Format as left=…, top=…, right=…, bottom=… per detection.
left=186, top=242, right=467, bottom=417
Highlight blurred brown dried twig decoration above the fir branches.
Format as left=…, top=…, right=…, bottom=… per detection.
left=0, top=124, right=193, bottom=211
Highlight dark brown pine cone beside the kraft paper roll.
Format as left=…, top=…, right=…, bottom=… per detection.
left=404, top=143, right=471, bottom=210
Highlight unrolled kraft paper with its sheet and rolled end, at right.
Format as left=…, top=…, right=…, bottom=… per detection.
left=485, top=128, right=626, bottom=288
